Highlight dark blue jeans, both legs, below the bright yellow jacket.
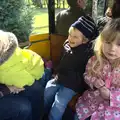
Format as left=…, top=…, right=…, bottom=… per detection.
left=0, top=81, right=44, bottom=120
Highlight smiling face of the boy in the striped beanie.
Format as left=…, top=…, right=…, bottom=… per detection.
left=68, top=29, right=84, bottom=47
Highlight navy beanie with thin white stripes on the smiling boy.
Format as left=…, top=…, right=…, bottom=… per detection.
left=71, top=16, right=98, bottom=40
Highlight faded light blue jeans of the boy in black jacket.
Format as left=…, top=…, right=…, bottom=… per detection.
left=44, top=79, right=76, bottom=120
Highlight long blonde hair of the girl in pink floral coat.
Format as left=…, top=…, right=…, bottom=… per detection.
left=92, top=18, right=120, bottom=73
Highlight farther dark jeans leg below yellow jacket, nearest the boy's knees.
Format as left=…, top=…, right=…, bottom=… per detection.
left=18, top=80, right=44, bottom=120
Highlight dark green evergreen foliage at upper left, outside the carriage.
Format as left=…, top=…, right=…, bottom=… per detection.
left=0, top=0, right=32, bottom=42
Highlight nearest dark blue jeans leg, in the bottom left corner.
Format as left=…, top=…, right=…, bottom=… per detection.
left=0, top=96, right=32, bottom=120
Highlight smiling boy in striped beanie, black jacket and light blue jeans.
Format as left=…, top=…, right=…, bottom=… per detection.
left=44, top=16, right=98, bottom=120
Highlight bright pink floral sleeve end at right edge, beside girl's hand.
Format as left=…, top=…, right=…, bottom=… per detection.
left=110, top=91, right=120, bottom=108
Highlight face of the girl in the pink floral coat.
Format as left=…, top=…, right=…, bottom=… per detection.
left=102, top=38, right=120, bottom=62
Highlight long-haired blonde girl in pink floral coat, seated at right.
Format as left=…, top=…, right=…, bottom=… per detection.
left=76, top=18, right=120, bottom=120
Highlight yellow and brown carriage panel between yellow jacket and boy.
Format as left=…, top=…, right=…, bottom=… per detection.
left=29, top=34, right=67, bottom=68
